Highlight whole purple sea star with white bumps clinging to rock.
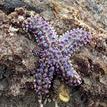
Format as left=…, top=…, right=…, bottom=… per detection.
left=23, top=16, right=91, bottom=97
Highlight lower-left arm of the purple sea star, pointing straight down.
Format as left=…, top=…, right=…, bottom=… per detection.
left=34, top=58, right=55, bottom=99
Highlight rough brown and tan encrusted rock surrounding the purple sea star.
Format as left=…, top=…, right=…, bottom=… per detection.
left=0, top=0, right=107, bottom=107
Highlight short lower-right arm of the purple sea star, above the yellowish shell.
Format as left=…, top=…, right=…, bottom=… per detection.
left=60, top=58, right=82, bottom=86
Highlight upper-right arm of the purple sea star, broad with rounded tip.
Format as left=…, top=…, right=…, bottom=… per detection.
left=59, top=28, right=91, bottom=56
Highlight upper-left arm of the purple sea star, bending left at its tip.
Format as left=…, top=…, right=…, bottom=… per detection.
left=23, top=16, right=57, bottom=49
